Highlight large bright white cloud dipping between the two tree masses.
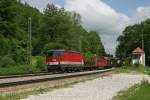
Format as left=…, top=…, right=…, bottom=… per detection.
left=65, top=0, right=130, bottom=54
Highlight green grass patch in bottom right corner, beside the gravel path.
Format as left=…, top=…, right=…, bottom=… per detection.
left=113, top=81, right=150, bottom=100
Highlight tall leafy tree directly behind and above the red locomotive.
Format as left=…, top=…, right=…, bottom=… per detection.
left=40, top=5, right=81, bottom=50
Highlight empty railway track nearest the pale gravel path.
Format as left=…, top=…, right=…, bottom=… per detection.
left=0, top=68, right=113, bottom=88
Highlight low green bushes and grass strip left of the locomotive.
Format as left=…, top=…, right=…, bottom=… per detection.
left=0, top=56, right=47, bottom=75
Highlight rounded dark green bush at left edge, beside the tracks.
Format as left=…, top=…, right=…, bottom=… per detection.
left=0, top=55, right=16, bottom=67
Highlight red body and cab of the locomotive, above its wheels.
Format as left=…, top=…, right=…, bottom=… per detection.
left=47, top=50, right=83, bottom=65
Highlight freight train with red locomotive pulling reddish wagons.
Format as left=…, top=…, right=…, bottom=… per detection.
left=46, top=50, right=117, bottom=72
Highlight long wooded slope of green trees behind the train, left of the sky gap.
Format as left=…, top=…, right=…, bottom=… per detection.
left=0, top=0, right=105, bottom=66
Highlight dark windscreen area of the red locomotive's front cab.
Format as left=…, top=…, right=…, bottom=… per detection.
left=47, top=50, right=63, bottom=58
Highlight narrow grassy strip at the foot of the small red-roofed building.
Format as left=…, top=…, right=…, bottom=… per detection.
left=115, top=66, right=150, bottom=74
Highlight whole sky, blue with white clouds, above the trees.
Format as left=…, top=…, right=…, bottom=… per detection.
left=22, top=0, right=150, bottom=54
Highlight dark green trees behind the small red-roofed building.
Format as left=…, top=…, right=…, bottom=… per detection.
left=116, top=19, right=150, bottom=66
